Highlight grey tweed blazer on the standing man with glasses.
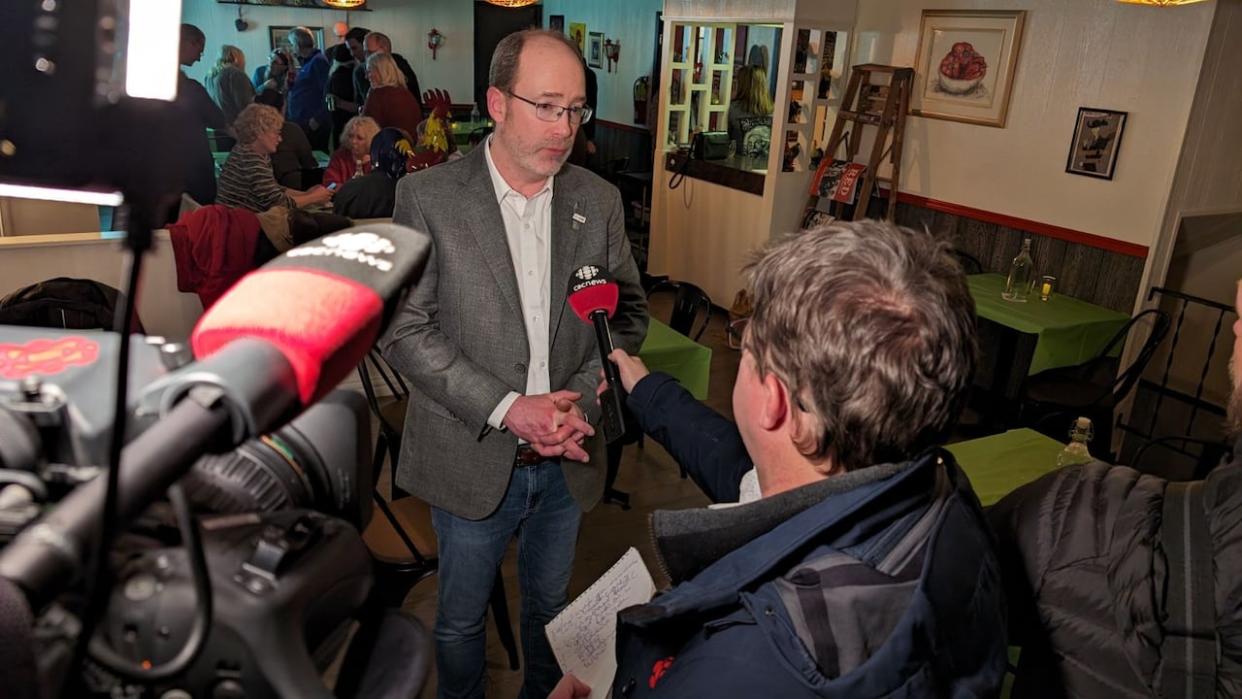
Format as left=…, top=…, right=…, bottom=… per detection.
left=380, top=145, right=648, bottom=519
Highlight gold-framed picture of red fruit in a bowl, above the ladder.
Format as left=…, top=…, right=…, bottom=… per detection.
left=910, top=10, right=1026, bottom=127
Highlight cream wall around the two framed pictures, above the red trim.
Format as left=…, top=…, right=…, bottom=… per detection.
left=853, top=0, right=1212, bottom=246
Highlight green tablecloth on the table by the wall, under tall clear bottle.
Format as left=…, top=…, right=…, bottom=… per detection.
left=966, top=273, right=1129, bottom=375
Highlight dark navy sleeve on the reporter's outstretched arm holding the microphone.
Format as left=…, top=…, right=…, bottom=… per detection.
left=626, top=371, right=754, bottom=503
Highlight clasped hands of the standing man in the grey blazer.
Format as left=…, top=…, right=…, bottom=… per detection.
left=504, top=391, right=595, bottom=462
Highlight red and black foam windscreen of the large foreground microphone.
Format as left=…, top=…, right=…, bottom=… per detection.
left=190, top=223, right=431, bottom=405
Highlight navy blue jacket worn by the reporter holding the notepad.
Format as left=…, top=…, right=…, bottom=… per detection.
left=612, top=374, right=1006, bottom=698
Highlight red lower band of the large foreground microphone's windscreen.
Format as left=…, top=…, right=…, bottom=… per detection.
left=190, top=267, right=384, bottom=405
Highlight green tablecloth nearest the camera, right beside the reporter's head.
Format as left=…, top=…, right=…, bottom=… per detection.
left=945, top=428, right=1066, bottom=507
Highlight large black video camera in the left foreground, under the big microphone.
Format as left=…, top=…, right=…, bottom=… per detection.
left=0, top=300, right=421, bottom=697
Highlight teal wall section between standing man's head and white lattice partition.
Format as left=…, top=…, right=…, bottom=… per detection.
left=543, top=0, right=663, bottom=124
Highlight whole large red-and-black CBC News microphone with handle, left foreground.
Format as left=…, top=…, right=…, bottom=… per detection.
left=0, top=223, right=431, bottom=607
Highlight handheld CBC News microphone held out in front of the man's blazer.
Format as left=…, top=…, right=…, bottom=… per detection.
left=565, top=264, right=626, bottom=443
